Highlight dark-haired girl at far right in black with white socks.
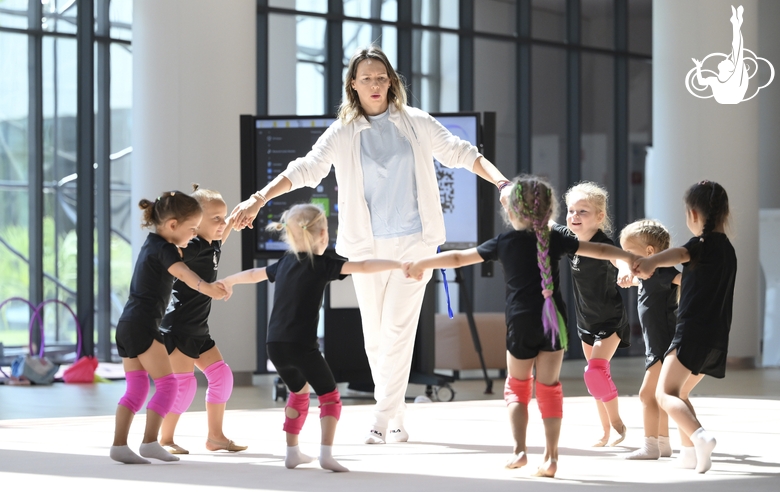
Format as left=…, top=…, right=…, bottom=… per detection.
left=632, top=181, right=737, bottom=473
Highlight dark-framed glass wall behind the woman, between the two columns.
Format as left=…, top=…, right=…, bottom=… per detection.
left=259, top=0, right=652, bottom=362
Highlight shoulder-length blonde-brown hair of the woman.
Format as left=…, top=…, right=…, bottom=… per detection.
left=338, top=44, right=406, bottom=124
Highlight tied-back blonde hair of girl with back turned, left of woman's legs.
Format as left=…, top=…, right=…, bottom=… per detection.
left=266, top=203, right=328, bottom=262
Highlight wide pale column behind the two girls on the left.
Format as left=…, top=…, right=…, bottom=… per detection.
left=132, top=0, right=257, bottom=384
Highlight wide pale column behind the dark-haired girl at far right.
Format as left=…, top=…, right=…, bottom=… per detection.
left=646, top=0, right=760, bottom=365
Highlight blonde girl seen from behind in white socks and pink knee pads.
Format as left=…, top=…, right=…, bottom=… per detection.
left=220, top=203, right=401, bottom=472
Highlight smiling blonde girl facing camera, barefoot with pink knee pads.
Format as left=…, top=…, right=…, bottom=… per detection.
left=553, top=181, right=630, bottom=447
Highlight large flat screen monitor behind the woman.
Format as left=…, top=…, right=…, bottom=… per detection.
left=241, top=113, right=492, bottom=258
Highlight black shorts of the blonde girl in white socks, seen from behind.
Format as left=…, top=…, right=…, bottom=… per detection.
left=265, top=342, right=336, bottom=395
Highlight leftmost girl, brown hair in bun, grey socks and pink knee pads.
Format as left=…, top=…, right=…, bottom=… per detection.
left=110, top=191, right=226, bottom=464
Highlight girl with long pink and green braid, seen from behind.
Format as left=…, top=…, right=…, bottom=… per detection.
left=404, top=176, right=633, bottom=477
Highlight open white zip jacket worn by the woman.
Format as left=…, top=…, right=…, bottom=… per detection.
left=282, top=104, right=481, bottom=260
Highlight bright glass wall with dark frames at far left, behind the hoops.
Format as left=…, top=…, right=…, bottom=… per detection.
left=0, top=0, right=133, bottom=363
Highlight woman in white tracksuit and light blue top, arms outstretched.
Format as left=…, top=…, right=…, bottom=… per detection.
left=232, top=46, right=509, bottom=444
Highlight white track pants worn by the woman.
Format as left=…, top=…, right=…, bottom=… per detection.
left=350, top=234, right=436, bottom=428
